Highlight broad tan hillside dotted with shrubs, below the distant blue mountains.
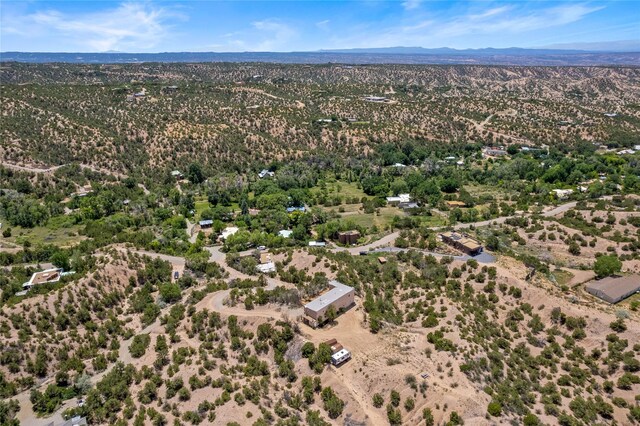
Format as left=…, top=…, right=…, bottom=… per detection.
left=0, top=63, right=640, bottom=174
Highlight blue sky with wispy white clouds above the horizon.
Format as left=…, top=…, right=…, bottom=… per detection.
left=0, top=0, right=640, bottom=52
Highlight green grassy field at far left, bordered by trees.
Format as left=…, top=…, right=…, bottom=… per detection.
left=6, top=216, right=84, bottom=247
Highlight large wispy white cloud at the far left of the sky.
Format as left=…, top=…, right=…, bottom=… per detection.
left=3, top=3, right=185, bottom=51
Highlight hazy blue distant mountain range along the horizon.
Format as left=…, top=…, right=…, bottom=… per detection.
left=0, top=47, right=640, bottom=66
